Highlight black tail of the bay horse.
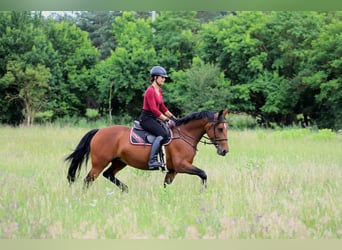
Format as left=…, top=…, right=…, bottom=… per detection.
left=65, top=129, right=99, bottom=184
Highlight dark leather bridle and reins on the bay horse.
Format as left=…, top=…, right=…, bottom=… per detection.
left=172, top=119, right=228, bottom=151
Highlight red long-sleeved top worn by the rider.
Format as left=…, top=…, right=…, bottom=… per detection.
left=143, top=85, right=168, bottom=117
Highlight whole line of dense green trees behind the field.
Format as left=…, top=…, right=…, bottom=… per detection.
left=0, top=11, right=342, bottom=129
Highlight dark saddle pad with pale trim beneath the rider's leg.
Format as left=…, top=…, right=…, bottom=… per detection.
left=129, top=121, right=172, bottom=145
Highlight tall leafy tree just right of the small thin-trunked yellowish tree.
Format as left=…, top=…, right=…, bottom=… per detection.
left=47, top=19, right=99, bottom=117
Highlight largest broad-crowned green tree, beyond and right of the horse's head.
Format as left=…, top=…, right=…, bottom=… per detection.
left=198, top=12, right=324, bottom=125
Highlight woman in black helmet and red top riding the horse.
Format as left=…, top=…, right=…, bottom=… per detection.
left=140, top=66, right=176, bottom=170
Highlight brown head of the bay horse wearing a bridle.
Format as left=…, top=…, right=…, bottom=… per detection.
left=206, top=109, right=229, bottom=156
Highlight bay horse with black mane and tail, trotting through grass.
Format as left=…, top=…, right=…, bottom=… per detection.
left=65, top=109, right=229, bottom=192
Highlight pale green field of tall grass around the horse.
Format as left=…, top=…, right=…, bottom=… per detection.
left=0, top=127, right=342, bottom=239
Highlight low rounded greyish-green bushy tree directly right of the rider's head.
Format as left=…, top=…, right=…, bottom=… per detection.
left=165, top=58, right=231, bottom=115
